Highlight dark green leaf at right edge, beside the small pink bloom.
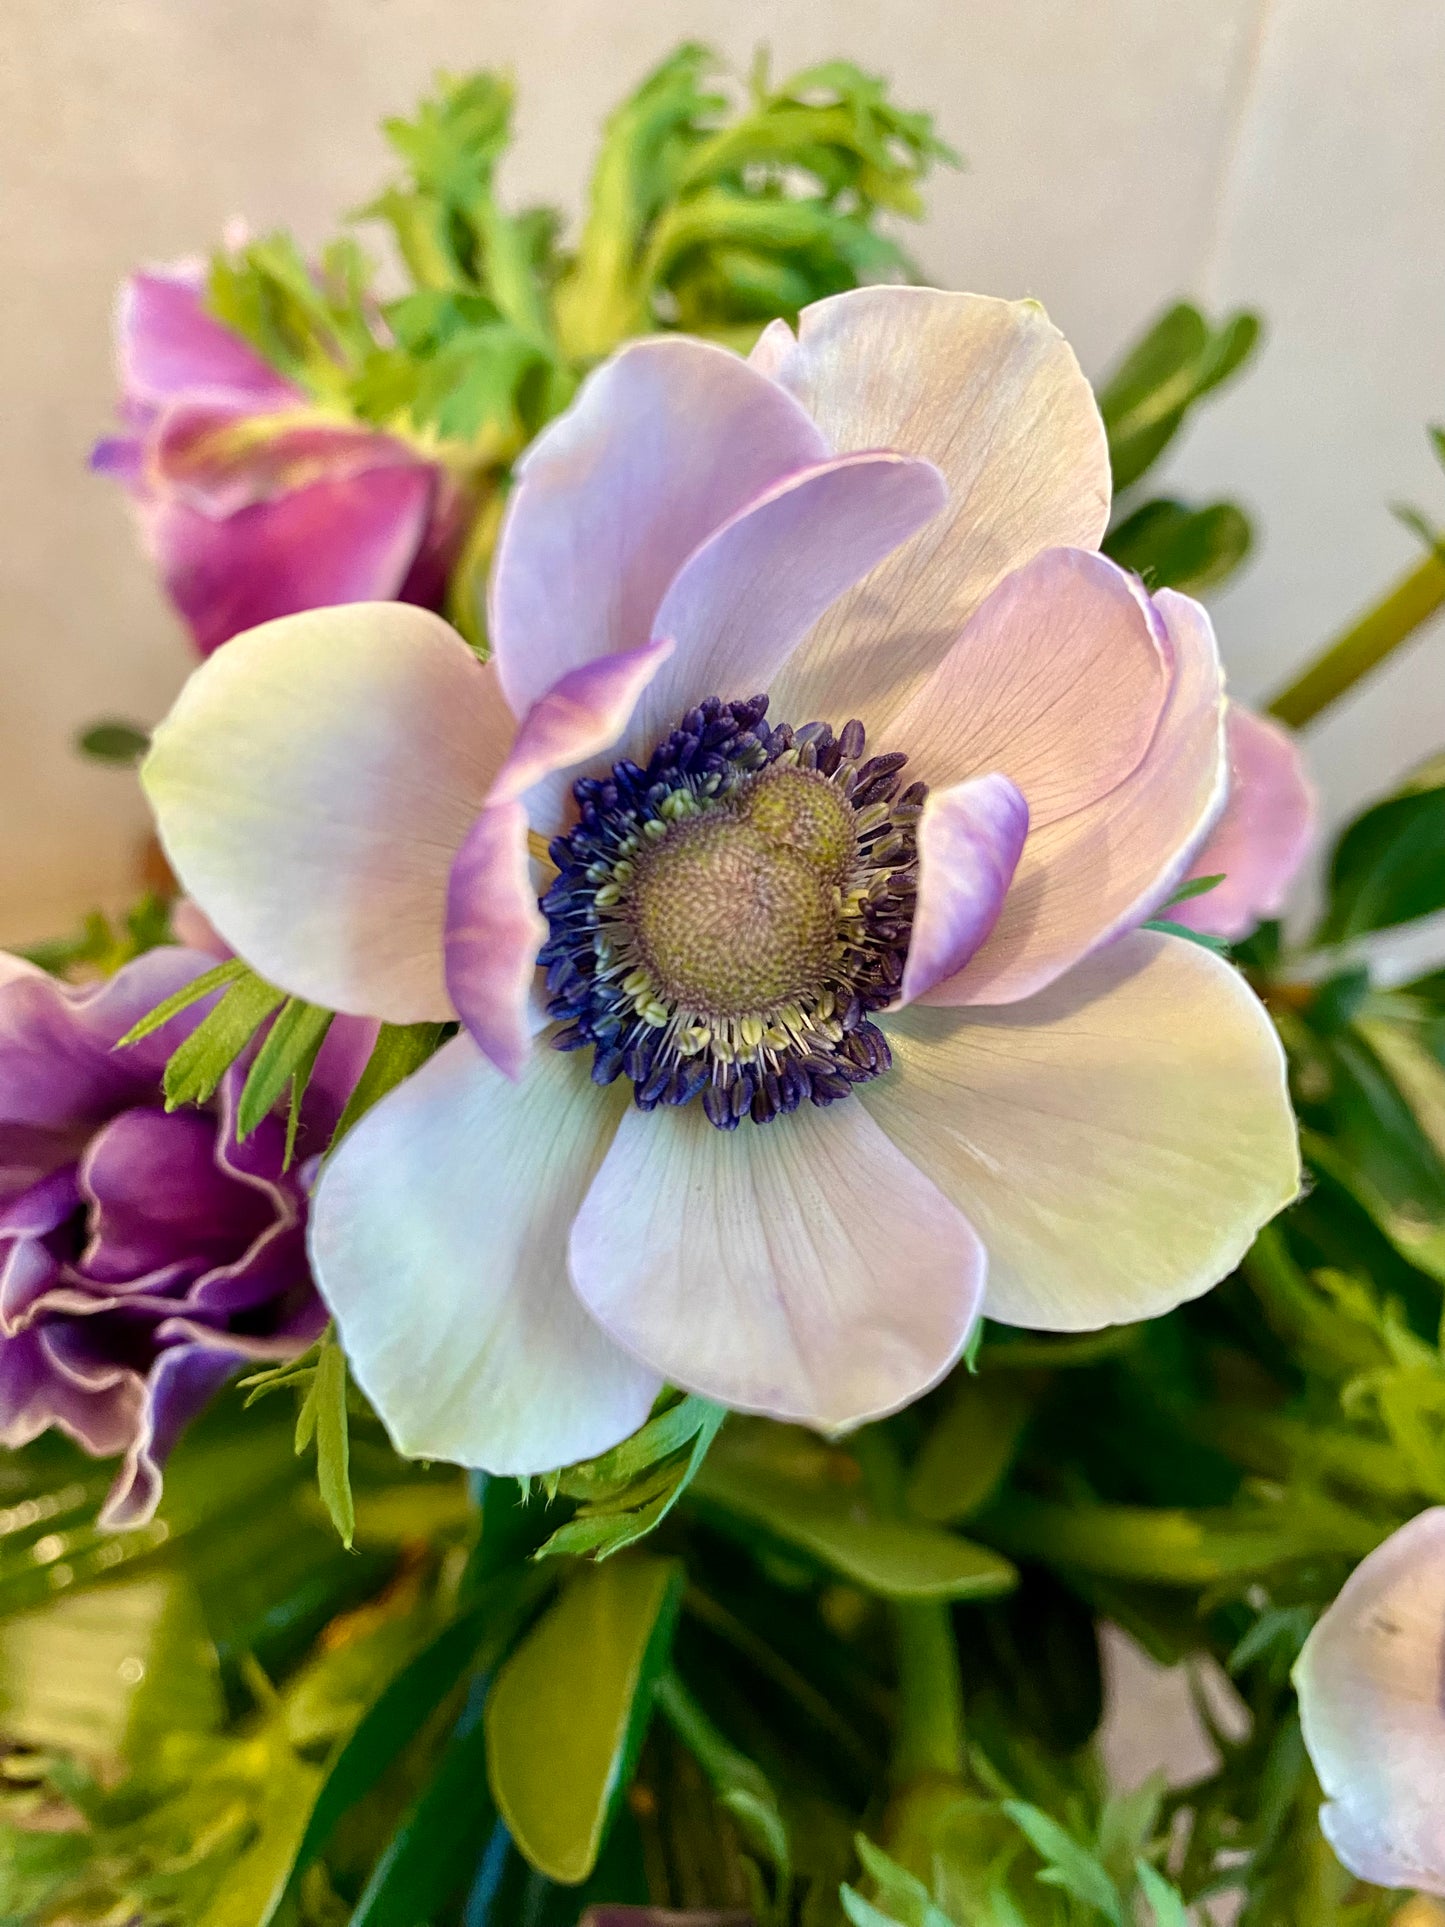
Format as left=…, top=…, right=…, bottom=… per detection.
left=1316, top=786, right=1445, bottom=944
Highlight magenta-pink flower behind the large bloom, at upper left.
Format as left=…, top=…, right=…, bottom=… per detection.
left=91, top=266, right=466, bottom=655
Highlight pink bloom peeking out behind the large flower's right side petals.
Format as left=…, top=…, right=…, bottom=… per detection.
left=1169, top=703, right=1318, bottom=942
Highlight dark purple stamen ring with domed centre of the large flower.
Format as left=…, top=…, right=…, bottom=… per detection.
left=539, top=696, right=927, bottom=1131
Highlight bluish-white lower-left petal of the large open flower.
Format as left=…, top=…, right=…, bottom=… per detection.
left=310, top=1037, right=659, bottom=1476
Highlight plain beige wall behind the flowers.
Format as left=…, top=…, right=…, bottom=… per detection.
left=0, top=0, right=1445, bottom=942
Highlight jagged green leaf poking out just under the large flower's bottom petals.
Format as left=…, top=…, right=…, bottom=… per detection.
left=536, top=1397, right=726, bottom=1559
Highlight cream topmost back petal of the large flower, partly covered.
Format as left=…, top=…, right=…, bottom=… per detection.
left=755, top=287, right=1110, bottom=732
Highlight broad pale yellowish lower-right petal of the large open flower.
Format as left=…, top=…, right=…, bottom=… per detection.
left=859, top=931, right=1299, bottom=1332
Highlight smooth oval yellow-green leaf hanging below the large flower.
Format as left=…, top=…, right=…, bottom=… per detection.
left=486, top=1553, right=682, bottom=1883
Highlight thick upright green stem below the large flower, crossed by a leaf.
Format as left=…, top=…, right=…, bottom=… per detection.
left=848, top=1424, right=967, bottom=1786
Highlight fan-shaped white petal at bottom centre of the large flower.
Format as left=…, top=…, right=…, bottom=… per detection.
left=570, top=1100, right=985, bottom=1432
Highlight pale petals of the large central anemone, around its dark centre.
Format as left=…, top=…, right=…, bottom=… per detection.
left=145, top=289, right=1299, bottom=1474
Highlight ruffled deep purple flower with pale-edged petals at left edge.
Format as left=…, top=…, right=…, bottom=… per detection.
left=0, top=948, right=374, bottom=1526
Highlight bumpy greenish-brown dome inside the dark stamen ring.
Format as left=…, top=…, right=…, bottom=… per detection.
left=626, top=769, right=857, bottom=1017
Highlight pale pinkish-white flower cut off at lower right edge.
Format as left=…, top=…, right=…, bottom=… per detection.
left=1295, top=1505, right=1445, bottom=1894
